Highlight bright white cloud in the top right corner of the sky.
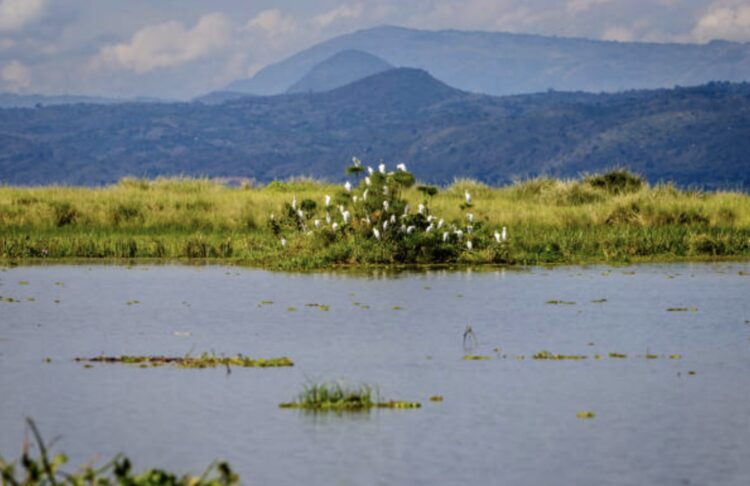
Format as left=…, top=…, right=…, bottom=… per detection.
left=692, top=0, right=750, bottom=42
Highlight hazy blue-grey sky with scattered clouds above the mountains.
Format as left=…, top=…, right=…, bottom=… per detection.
left=0, top=0, right=750, bottom=99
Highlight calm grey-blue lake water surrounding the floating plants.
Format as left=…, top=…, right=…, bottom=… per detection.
left=0, top=263, right=750, bottom=486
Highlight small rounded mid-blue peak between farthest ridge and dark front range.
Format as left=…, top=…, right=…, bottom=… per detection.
left=287, top=49, right=393, bottom=93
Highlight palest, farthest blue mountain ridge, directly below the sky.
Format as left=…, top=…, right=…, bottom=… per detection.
left=226, top=26, right=750, bottom=95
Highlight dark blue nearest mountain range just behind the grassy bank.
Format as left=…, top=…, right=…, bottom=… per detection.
left=0, top=68, right=750, bottom=188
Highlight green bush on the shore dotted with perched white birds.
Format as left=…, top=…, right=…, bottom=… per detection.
left=269, top=158, right=511, bottom=263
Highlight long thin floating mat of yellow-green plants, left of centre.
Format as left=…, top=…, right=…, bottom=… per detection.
left=75, top=353, right=294, bottom=368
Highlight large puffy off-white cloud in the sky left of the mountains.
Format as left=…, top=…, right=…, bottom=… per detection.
left=93, top=13, right=232, bottom=73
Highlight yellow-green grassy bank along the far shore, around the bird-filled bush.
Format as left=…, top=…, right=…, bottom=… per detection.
left=0, top=174, right=750, bottom=270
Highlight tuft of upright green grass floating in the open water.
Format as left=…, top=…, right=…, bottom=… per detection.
left=279, top=383, right=422, bottom=412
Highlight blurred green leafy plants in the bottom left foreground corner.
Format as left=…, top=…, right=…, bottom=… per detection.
left=0, top=419, right=239, bottom=486
